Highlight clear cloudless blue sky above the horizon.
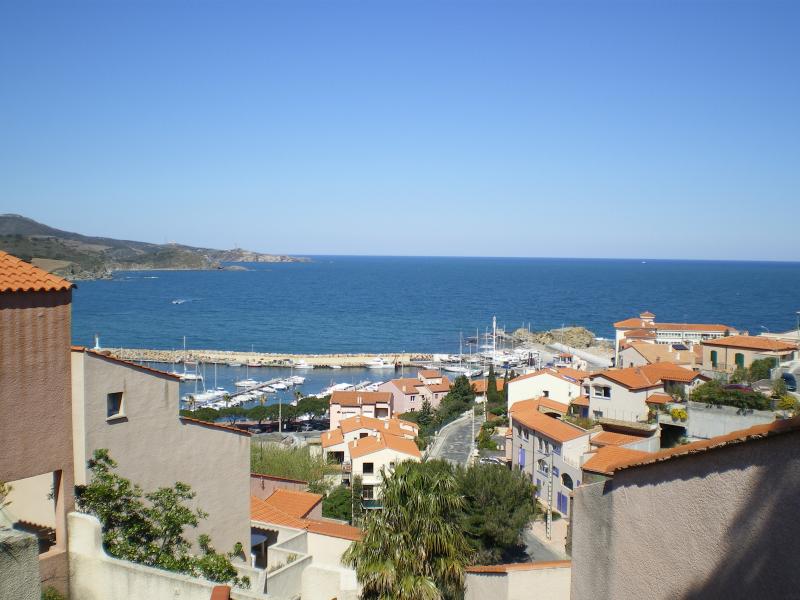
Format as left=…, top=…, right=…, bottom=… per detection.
left=0, top=0, right=800, bottom=260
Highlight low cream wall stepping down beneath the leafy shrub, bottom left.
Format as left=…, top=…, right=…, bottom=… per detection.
left=69, top=513, right=264, bottom=600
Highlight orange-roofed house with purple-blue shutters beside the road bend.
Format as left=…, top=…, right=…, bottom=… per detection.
left=510, top=400, right=591, bottom=515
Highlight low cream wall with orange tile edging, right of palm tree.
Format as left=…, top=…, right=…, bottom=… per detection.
left=464, top=561, right=571, bottom=600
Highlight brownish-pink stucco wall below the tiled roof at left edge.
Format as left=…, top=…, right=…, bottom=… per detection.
left=0, top=291, right=75, bottom=592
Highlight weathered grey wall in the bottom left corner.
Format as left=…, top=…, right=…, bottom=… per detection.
left=0, top=529, right=41, bottom=600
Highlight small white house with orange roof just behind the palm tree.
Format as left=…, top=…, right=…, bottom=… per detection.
left=344, top=433, right=422, bottom=508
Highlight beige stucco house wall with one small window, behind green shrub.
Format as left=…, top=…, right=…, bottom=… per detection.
left=71, top=346, right=250, bottom=552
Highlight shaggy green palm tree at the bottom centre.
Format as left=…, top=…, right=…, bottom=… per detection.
left=343, top=461, right=471, bottom=600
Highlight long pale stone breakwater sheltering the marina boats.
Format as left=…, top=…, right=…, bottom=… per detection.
left=108, top=348, right=433, bottom=367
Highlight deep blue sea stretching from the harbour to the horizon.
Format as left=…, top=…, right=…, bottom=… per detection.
left=72, top=256, right=800, bottom=406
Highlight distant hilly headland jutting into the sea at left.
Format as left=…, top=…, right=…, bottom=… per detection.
left=0, top=214, right=308, bottom=279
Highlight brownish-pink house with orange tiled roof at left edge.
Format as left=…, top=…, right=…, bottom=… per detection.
left=0, top=251, right=74, bottom=594
